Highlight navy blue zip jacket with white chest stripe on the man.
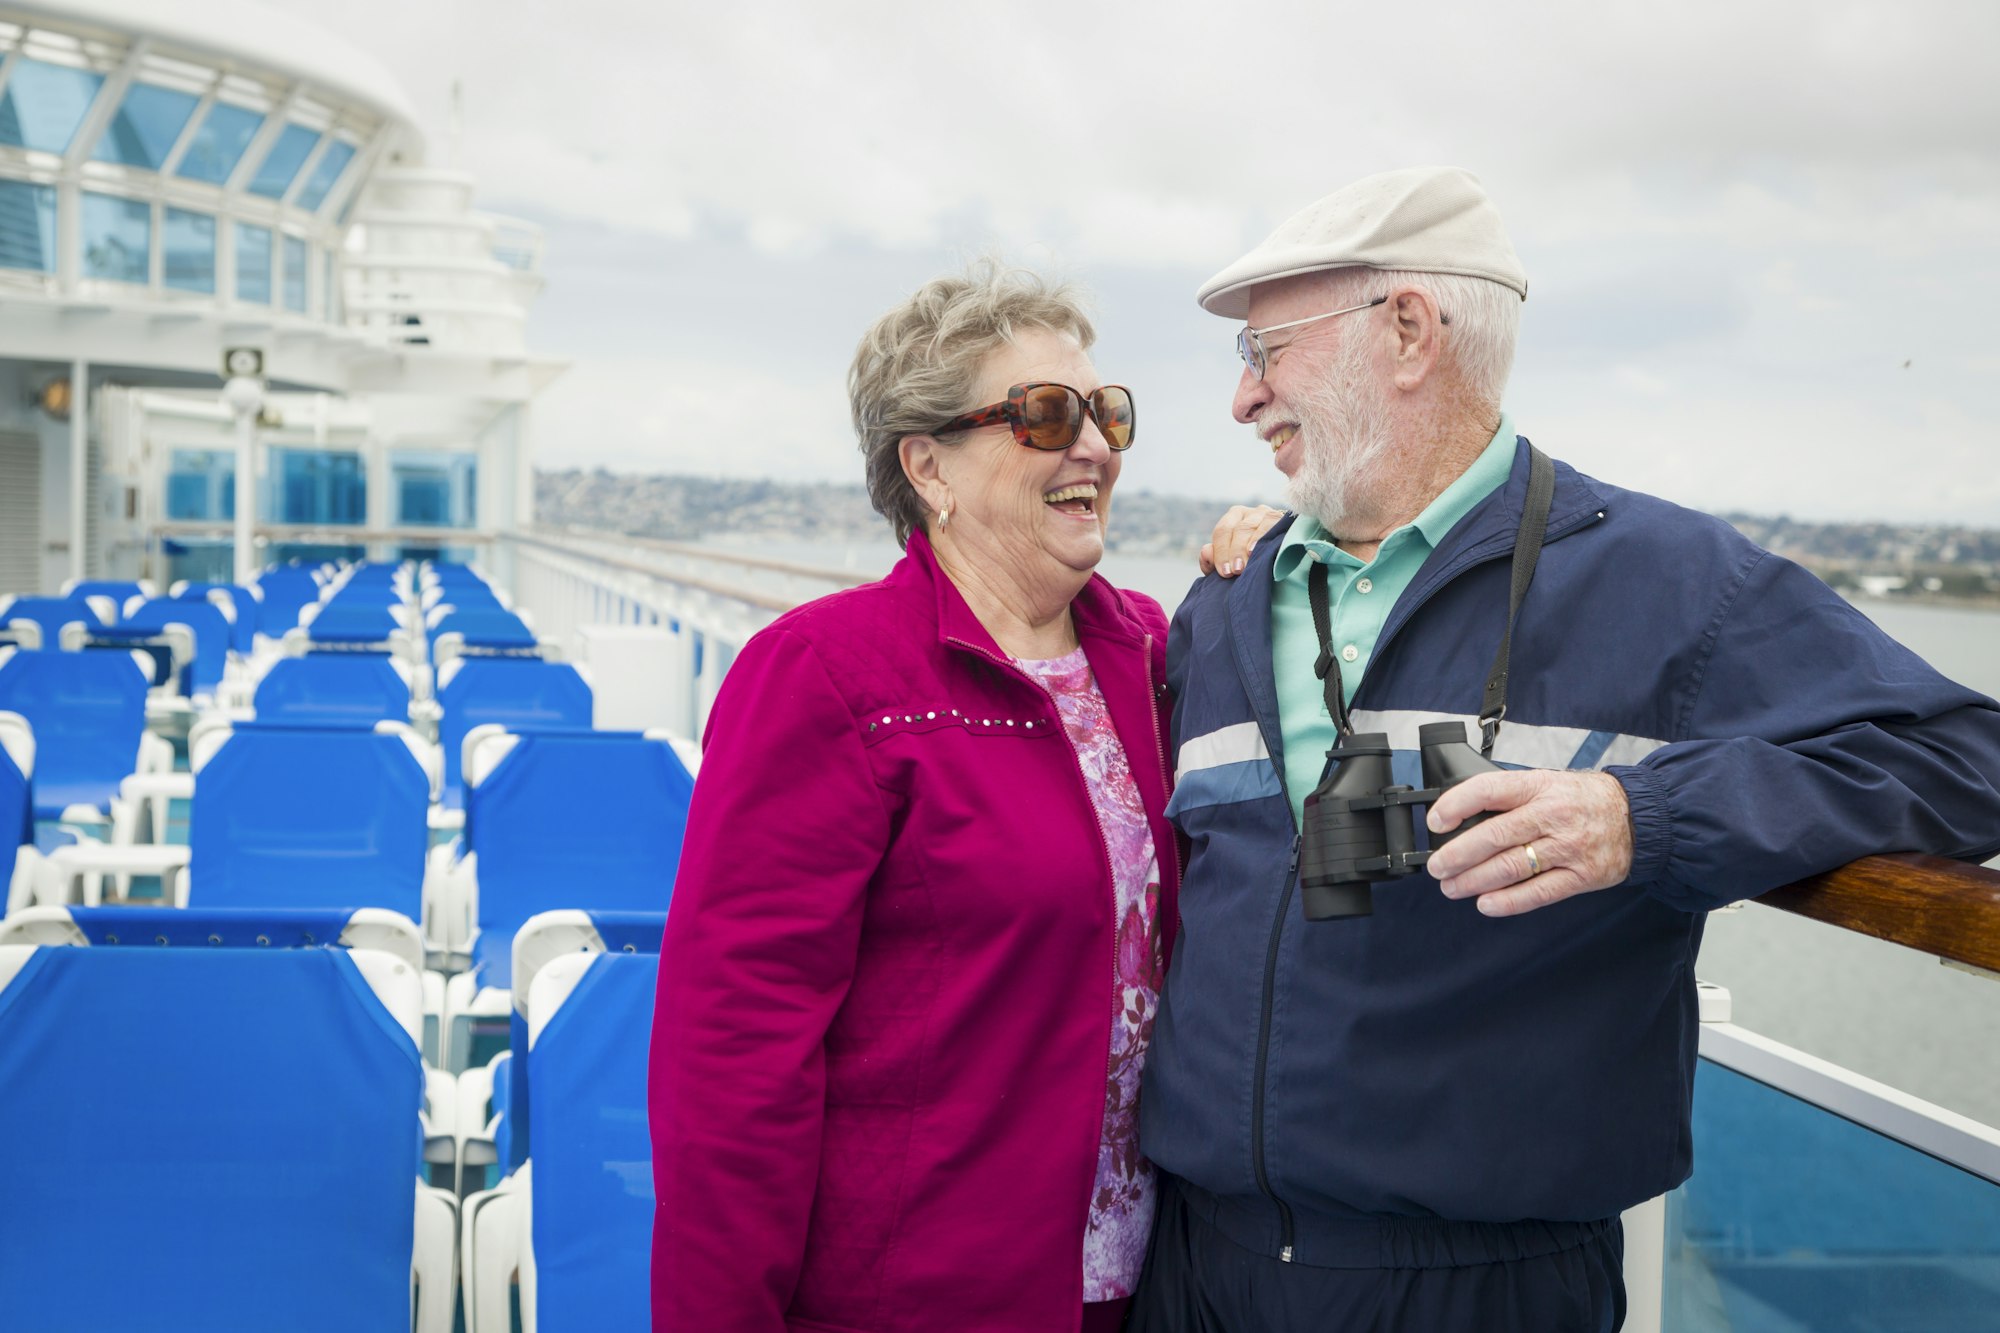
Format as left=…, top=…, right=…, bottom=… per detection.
left=1140, top=440, right=2000, bottom=1261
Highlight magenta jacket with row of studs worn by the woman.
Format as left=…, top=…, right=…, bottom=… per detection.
left=652, top=532, right=1180, bottom=1333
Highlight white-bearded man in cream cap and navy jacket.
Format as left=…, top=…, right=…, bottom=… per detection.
left=1130, top=168, right=2000, bottom=1333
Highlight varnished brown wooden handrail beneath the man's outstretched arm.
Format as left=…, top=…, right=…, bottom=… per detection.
left=1758, top=853, right=2000, bottom=973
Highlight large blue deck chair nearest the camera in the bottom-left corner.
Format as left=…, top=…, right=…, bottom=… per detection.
left=0, top=907, right=456, bottom=1333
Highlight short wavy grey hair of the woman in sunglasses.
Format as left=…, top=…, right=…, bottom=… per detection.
left=848, top=258, right=1098, bottom=546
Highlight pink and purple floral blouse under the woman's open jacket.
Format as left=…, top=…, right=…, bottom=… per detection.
left=1020, top=648, right=1164, bottom=1303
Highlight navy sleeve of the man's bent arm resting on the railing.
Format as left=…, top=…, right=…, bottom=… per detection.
left=1610, top=552, right=2000, bottom=911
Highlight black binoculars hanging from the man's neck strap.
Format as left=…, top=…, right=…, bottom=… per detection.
left=1298, top=723, right=1502, bottom=921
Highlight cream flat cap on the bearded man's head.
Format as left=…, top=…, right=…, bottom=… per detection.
left=1194, top=166, right=1528, bottom=320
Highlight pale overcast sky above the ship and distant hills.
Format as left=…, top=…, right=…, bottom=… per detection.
left=268, top=0, right=2000, bottom=526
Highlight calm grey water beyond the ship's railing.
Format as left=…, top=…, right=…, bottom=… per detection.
left=714, top=536, right=2000, bottom=1125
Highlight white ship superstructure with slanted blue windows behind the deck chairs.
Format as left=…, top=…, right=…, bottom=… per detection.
left=0, top=0, right=562, bottom=588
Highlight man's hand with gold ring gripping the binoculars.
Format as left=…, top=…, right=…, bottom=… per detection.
left=1426, top=769, right=1632, bottom=917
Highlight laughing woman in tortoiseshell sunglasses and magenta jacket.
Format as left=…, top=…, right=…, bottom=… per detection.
left=652, top=266, right=1178, bottom=1333
